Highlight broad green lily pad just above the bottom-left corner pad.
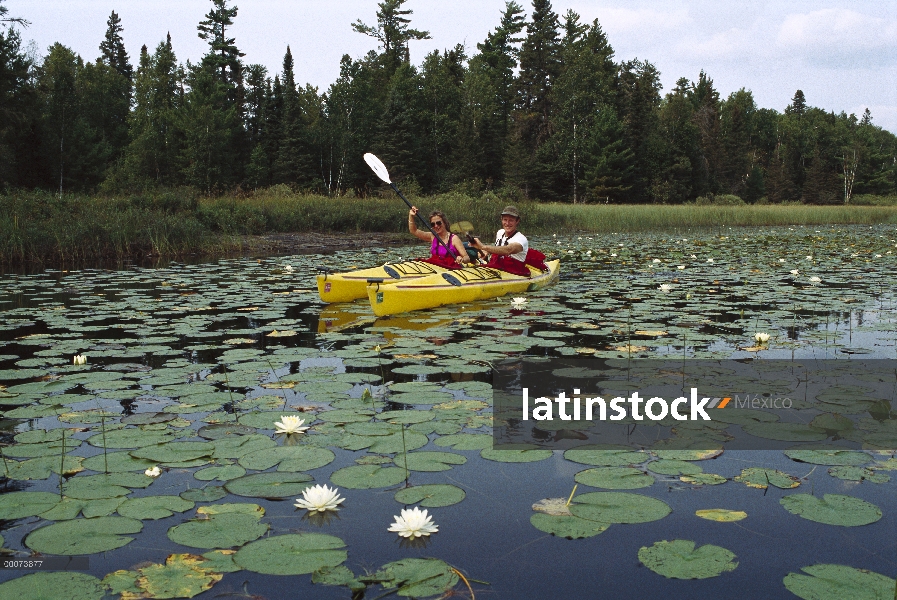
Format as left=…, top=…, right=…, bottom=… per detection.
left=25, top=517, right=143, bottom=556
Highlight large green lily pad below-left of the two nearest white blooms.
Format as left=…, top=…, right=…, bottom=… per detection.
left=234, top=533, right=348, bottom=575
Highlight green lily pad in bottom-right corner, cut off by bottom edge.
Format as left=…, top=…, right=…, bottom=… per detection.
left=782, top=564, right=897, bottom=600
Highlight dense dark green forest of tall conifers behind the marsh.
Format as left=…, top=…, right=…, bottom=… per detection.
left=0, top=0, right=897, bottom=204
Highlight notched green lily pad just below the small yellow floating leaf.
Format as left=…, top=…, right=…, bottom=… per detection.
left=638, top=540, right=738, bottom=579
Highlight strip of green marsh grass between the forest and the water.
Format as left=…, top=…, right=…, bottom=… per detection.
left=0, top=188, right=897, bottom=265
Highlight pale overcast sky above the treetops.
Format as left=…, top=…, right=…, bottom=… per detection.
left=6, top=0, right=897, bottom=133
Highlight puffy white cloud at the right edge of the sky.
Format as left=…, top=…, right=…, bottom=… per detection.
left=776, top=8, right=897, bottom=69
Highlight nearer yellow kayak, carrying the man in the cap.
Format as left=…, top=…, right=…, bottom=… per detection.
left=367, top=260, right=560, bottom=317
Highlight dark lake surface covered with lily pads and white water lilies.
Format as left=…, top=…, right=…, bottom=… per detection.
left=0, top=225, right=897, bottom=600
